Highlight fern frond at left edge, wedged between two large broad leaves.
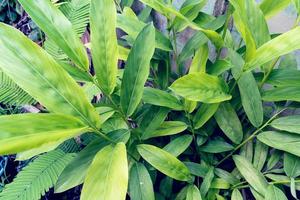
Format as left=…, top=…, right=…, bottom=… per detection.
left=0, top=71, right=36, bottom=106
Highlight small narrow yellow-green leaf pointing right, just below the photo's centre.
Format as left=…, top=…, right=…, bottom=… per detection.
left=142, top=121, right=188, bottom=139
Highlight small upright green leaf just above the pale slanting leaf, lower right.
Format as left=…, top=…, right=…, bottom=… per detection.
left=253, top=140, right=269, bottom=171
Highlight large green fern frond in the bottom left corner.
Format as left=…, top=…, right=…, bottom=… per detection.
left=0, top=150, right=74, bottom=200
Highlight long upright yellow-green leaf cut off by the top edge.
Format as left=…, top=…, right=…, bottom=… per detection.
left=90, top=0, right=118, bottom=94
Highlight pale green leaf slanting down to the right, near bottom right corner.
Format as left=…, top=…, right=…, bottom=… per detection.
left=233, top=155, right=268, bottom=196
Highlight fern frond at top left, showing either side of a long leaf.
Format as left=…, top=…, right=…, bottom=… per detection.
left=44, top=0, right=90, bottom=60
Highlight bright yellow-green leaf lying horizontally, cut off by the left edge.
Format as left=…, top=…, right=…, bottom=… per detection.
left=0, top=114, right=89, bottom=155
